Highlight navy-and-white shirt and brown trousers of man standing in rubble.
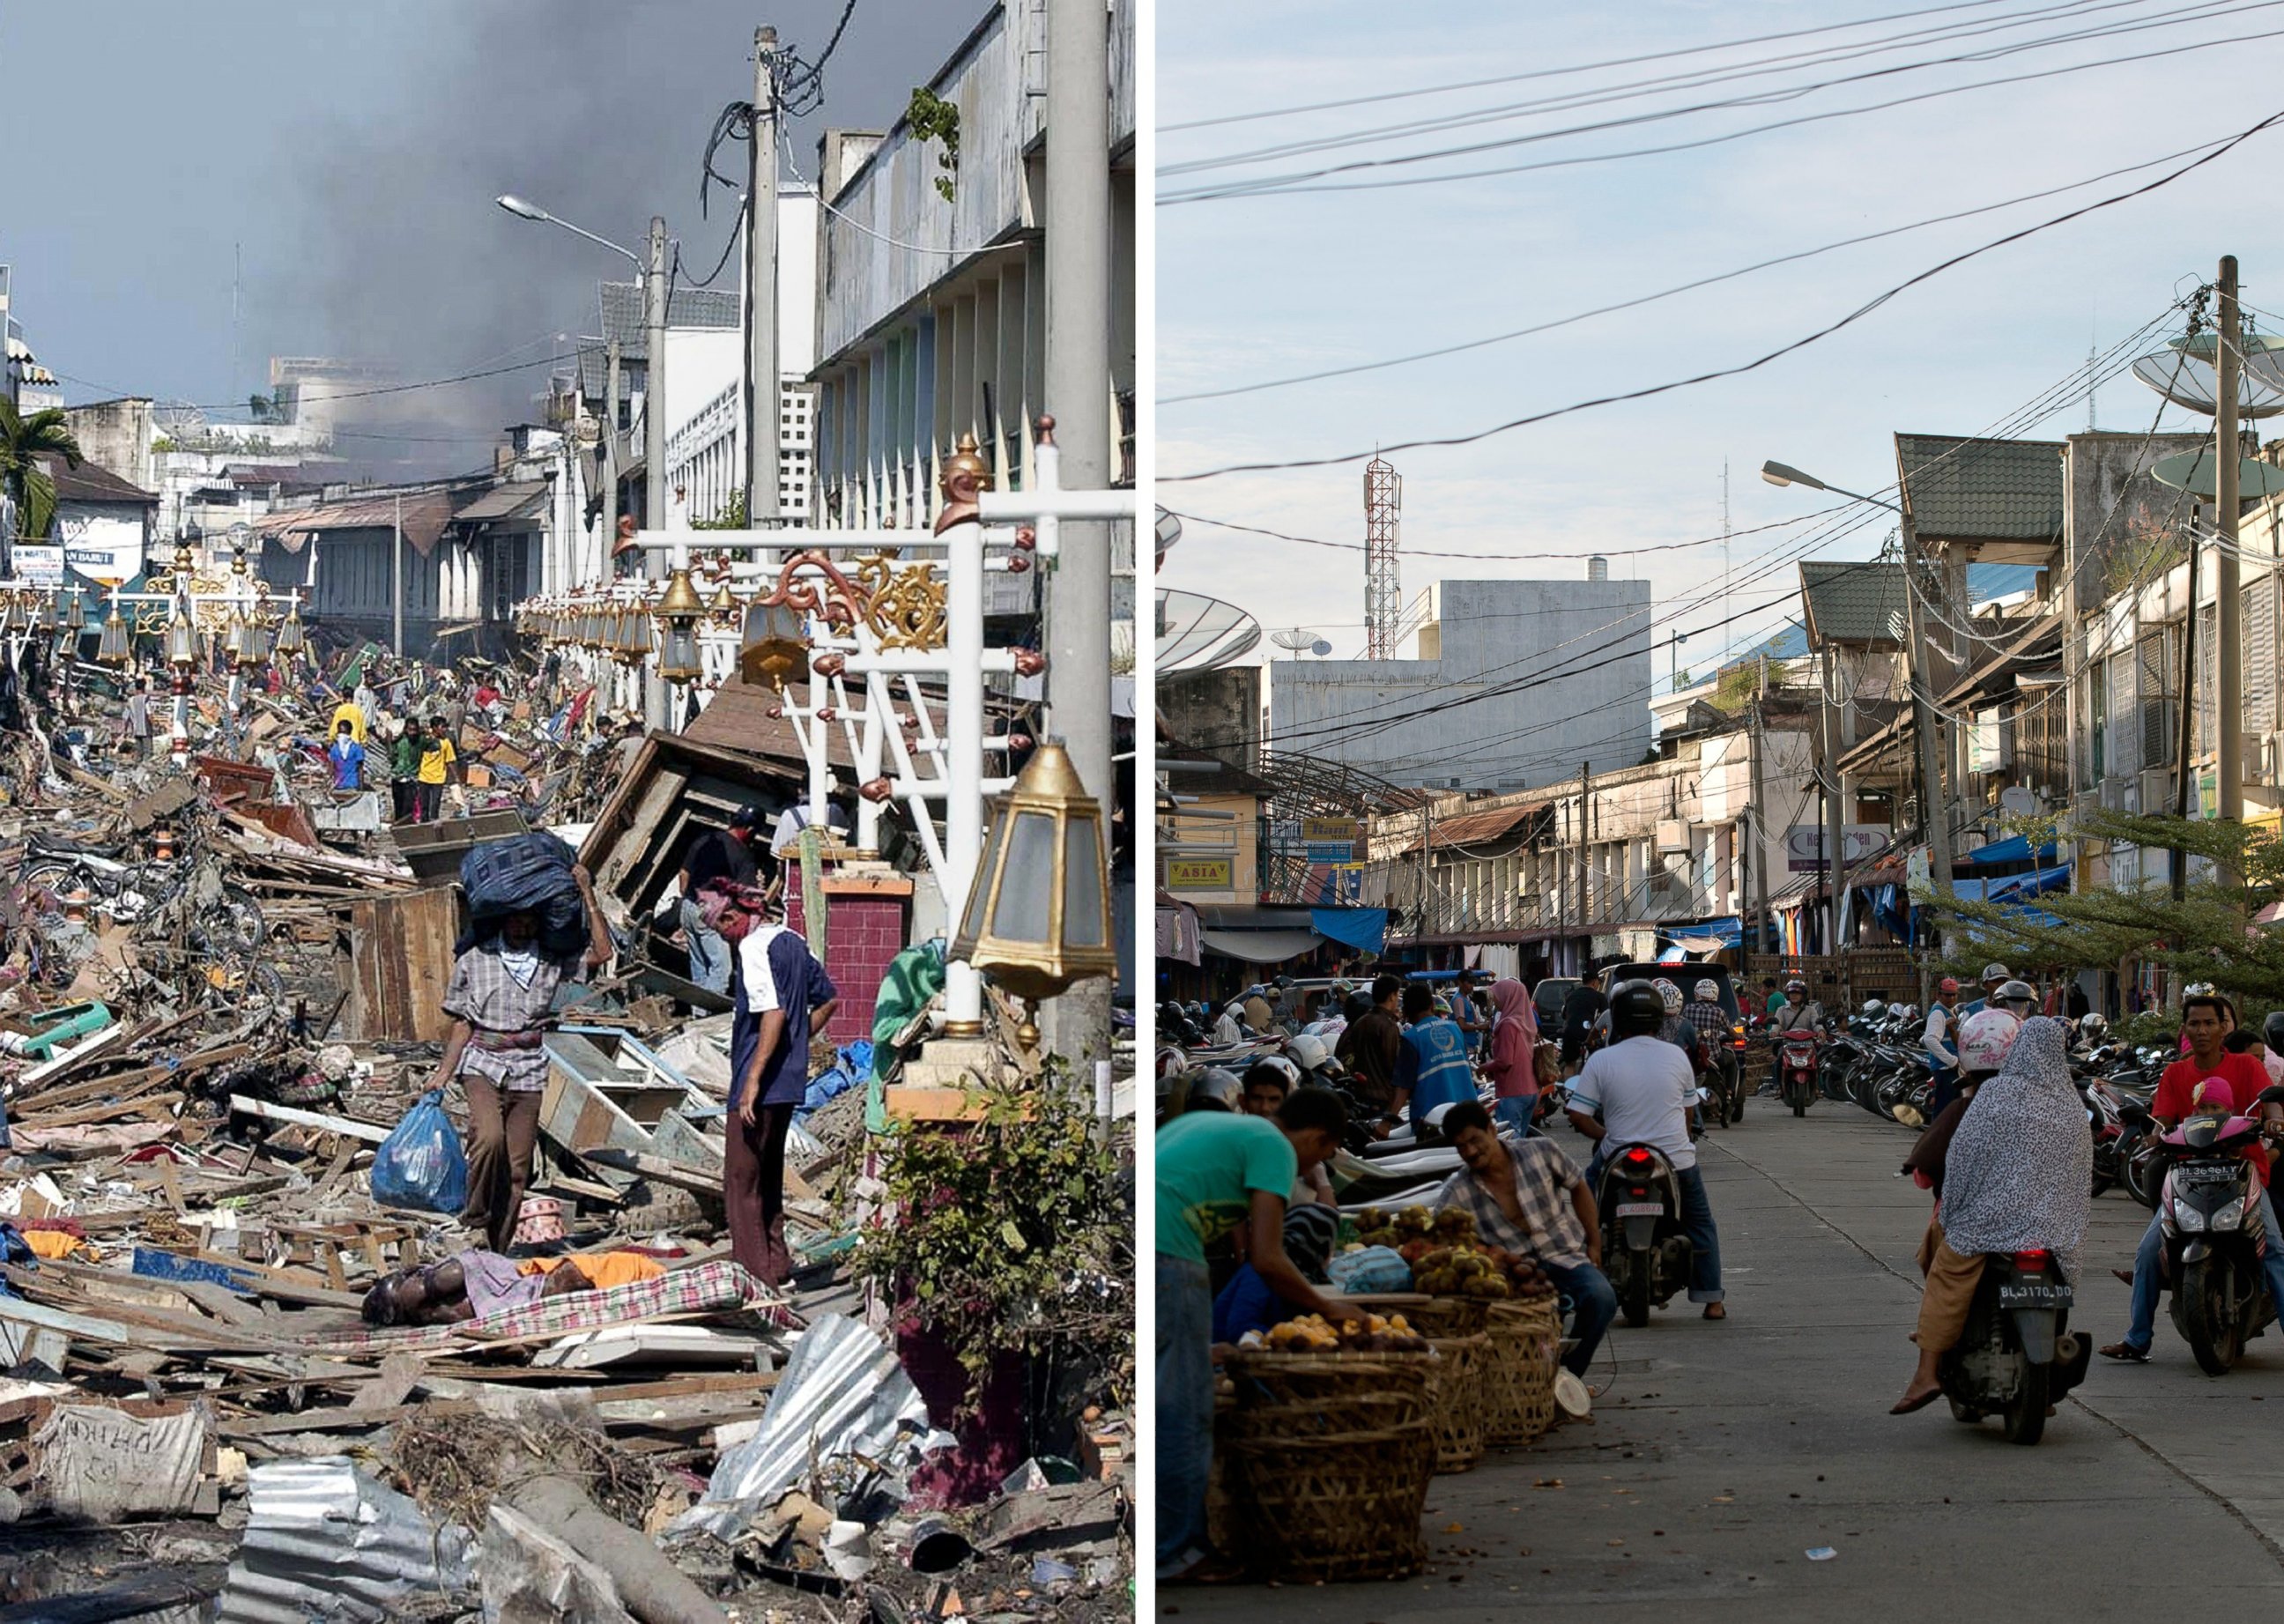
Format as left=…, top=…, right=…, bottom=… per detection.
left=722, top=900, right=841, bottom=1286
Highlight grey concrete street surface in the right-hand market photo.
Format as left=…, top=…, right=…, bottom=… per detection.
left=1187, top=1101, right=2284, bottom=1624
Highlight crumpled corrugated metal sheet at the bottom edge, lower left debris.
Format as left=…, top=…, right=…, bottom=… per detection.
left=215, top=1455, right=473, bottom=1624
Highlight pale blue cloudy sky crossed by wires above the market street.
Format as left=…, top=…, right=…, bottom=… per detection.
left=1158, top=0, right=2284, bottom=680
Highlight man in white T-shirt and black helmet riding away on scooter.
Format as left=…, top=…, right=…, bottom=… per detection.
left=1569, top=980, right=1726, bottom=1320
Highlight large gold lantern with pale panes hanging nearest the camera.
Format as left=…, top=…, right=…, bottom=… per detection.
left=953, top=740, right=1119, bottom=1003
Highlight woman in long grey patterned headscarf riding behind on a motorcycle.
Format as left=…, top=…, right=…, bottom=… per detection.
left=1891, top=1016, right=2095, bottom=1416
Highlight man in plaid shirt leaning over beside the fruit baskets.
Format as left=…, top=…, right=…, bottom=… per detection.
left=1435, top=1099, right=1617, bottom=1377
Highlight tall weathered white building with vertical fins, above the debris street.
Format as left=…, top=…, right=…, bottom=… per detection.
left=815, top=0, right=1135, bottom=527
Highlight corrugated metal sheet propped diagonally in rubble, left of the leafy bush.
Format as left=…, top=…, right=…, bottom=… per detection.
left=690, top=1313, right=927, bottom=1521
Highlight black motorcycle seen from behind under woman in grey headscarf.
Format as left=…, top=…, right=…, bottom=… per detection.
left=1937, top=1251, right=2095, bottom=1443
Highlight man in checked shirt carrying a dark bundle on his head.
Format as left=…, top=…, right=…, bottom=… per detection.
left=429, top=865, right=614, bottom=1251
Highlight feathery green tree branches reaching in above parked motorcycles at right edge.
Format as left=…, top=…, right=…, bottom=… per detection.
left=1914, top=813, right=2284, bottom=1010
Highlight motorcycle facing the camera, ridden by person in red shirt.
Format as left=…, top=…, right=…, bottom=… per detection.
left=2158, top=1117, right=2275, bottom=1375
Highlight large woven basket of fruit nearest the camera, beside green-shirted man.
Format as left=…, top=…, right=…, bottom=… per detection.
left=1231, top=1419, right=1436, bottom=1581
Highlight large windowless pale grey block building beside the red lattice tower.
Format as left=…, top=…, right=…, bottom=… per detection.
left=1268, top=580, right=1651, bottom=790
